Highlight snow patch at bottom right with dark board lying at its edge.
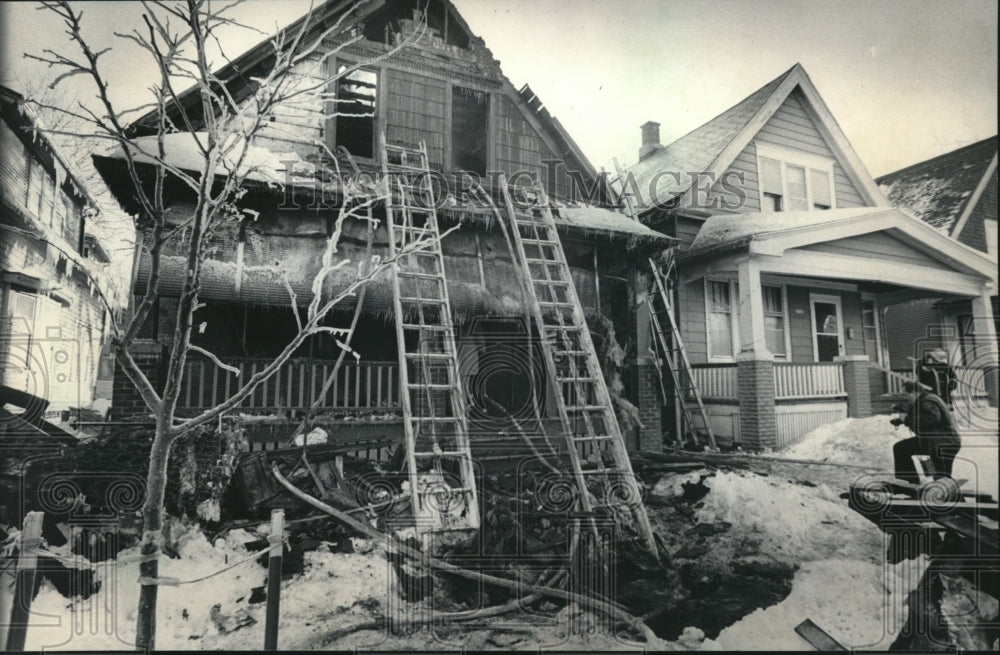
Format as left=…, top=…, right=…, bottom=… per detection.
left=702, top=556, right=927, bottom=651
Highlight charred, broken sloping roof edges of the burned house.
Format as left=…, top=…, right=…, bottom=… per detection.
left=122, top=0, right=597, bottom=179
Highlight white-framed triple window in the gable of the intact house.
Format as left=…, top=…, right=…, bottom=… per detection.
left=757, top=143, right=834, bottom=212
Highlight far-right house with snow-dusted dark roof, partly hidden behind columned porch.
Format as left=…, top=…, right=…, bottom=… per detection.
left=876, top=136, right=998, bottom=384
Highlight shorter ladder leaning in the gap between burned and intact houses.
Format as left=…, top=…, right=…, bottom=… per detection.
left=646, top=251, right=716, bottom=449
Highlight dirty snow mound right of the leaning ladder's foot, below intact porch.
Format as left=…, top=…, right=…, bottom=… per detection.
left=695, top=471, right=884, bottom=564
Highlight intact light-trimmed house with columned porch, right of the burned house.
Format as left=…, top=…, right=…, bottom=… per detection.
left=626, top=64, right=995, bottom=448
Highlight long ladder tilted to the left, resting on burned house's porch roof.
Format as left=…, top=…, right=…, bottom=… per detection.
left=500, top=177, right=659, bottom=559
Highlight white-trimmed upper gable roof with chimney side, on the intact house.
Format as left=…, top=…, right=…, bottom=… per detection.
left=629, top=64, right=888, bottom=213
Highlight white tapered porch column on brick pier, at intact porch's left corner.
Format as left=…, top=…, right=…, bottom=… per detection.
left=736, top=259, right=778, bottom=450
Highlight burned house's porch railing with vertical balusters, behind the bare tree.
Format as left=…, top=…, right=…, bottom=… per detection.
left=179, top=357, right=399, bottom=414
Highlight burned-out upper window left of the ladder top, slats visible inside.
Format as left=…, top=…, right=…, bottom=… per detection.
left=334, top=65, right=378, bottom=159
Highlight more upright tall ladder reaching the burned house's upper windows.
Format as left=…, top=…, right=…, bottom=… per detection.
left=380, top=134, right=479, bottom=538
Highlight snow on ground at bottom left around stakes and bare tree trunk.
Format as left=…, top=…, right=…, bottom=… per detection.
left=26, top=524, right=395, bottom=651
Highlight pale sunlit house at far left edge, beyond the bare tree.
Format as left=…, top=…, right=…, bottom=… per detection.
left=0, top=87, right=109, bottom=415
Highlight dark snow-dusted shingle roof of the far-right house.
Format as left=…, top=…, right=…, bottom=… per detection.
left=876, top=136, right=997, bottom=237
